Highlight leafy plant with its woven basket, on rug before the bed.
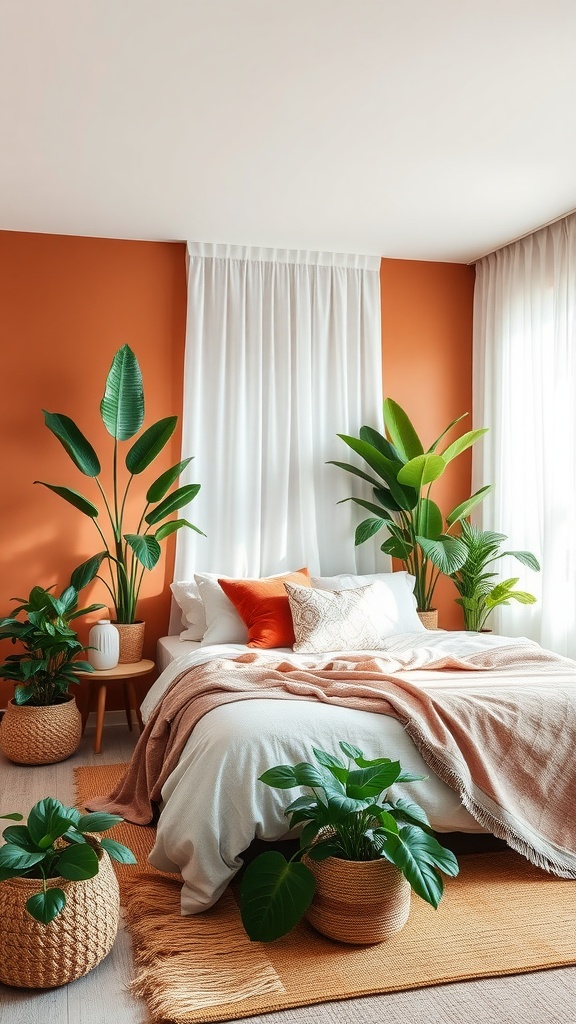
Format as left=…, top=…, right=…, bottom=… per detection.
left=240, top=741, right=458, bottom=943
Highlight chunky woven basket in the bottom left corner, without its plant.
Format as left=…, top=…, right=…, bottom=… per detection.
left=0, top=853, right=120, bottom=988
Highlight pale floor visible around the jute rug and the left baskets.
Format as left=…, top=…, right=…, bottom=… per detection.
left=0, top=724, right=576, bottom=1024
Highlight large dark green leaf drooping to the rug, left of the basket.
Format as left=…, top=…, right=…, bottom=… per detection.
left=240, top=851, right=316, bottom=942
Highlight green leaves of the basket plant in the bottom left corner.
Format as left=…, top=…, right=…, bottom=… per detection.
left=0, top=797, right=136, bottom=925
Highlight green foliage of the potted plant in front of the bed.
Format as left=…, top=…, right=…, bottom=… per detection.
left=240, top=741, right=458, bottom=942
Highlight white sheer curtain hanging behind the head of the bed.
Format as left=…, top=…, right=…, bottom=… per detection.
left=170, top=244, right=389, bottom=610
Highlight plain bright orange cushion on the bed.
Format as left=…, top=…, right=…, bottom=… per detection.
left=218, top=568, right=311, bottom=647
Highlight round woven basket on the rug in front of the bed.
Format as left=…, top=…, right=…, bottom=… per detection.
left=304, top=857, right=412, bottom=945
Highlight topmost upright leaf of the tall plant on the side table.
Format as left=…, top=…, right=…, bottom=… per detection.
left=100, top=345, right=145, bottom=441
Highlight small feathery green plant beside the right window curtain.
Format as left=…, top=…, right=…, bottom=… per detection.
left=451, top=519, right=540, bottom=633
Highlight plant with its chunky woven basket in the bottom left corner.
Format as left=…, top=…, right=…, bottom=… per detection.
left=0, top=797, right=136, bottom=988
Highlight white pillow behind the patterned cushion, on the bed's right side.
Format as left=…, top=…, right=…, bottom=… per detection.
left=311, top=571, right=426, bottom=637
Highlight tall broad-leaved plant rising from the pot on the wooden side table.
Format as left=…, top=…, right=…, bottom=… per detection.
left=34, top=345, right=205, bottom=623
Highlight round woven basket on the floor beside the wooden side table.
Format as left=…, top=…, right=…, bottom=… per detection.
left=0, top=696, right=82, bottom=765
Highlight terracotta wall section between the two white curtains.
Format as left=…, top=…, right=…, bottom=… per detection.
left=380, top=259, right=473, bottom=629
